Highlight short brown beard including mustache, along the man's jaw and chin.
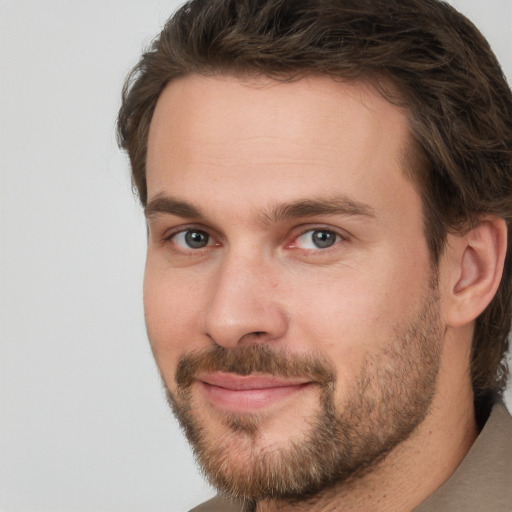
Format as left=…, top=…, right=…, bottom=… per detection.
left=164, top=286, right=441, bottom=504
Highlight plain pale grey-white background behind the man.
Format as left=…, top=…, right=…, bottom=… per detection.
left=0, top=0, right=512, bottom=512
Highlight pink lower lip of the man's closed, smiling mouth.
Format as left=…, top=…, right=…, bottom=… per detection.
left=200, top=381, right=312, bottom=412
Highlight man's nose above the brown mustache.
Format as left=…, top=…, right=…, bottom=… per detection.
left=204, top=251, right=288, bottom=348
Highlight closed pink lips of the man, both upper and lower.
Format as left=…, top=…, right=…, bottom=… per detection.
left=197, top=372, right=314, bottom=412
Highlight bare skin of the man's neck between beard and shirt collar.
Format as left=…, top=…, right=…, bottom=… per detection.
left=255, top=340, right=478, bottom=512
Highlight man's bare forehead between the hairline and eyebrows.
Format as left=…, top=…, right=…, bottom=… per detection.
left=147, top=75, right=418, bottom=216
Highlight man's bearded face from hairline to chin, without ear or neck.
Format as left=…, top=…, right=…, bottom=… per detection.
left=144, top=75, right=440, bottom=499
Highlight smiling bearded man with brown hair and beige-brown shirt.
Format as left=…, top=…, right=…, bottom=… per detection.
left=119, top=0, right=512, bottom=512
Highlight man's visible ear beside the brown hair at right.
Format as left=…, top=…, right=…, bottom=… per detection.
left=443, top=217, right=507, bottom=327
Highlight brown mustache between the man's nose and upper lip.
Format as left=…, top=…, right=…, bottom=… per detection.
left=175, top=344, right=335, bottom=389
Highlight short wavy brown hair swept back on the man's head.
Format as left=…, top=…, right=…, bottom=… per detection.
left=118, top=0, right=512, bottom=398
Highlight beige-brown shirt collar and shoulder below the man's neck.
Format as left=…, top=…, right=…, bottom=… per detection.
left=190, top=402, right=512, bottom=512
